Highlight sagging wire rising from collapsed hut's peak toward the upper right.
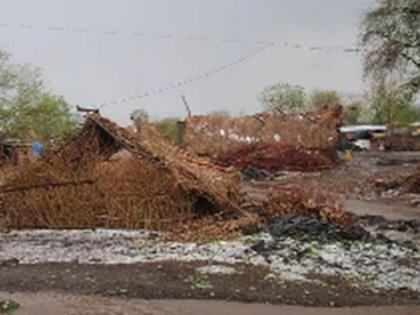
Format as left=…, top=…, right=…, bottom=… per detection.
left=99, top=44, right=275, bottom=109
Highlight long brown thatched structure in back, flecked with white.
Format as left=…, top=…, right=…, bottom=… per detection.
left=182, top=105, right=342, bottom=171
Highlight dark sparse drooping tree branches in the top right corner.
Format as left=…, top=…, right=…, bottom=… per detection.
left=361, top=0, right=420, bottom=93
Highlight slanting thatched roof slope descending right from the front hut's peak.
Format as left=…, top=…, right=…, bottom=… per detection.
left=87, top=114, right=240, bottom=215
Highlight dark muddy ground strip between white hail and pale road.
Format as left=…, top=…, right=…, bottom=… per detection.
left=0, top=262, right=420, bottom=307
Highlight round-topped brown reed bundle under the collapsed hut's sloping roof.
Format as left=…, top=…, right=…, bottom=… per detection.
left=94, top=151, right=196, bottom=230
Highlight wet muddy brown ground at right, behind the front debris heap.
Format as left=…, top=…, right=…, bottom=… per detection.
left=242, top=152, right=420, bottom=215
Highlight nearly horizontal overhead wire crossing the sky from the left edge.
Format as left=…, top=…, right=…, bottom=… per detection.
left=0, top=21, right=360, bottom=53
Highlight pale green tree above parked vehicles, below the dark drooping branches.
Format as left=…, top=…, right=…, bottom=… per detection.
left=368, top=80, right=418, bottom=126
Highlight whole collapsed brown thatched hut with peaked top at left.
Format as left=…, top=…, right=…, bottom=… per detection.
left=3, top=114, right=241, bottom=229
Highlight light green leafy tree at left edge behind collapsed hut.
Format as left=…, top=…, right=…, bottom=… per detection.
left=0, top=51, right=77, bottom=141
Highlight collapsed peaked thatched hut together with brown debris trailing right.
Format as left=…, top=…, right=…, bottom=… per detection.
left=2, top=113, right=353, bottom=240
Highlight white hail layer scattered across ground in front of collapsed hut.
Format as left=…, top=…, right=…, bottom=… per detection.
left=0, top=229, right=420, bottom=292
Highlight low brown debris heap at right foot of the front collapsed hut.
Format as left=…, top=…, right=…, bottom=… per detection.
left=170, top=186, right=358, bottom=241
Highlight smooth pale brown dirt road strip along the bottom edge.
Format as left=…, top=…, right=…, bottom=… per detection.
left=0, top=293, right=420, bottom=315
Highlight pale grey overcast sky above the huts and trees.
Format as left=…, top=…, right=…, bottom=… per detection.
left=0, top=0, right=374, bottom=123
